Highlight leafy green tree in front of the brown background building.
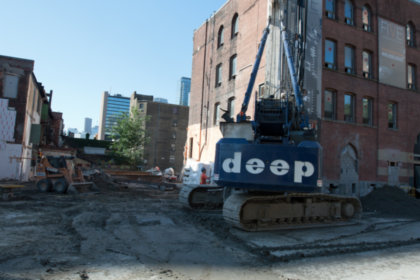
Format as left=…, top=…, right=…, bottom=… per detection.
left=111, top=107, right=149, bottom=166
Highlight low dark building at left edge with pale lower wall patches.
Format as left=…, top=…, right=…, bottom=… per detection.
left=0, top=56, right=62, bottom=181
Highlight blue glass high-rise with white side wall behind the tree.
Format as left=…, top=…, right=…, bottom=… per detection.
left=98, top=91, right=130, bottom=140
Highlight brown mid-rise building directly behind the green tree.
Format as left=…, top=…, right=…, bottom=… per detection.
left=130, top=92, right=188, bottom=173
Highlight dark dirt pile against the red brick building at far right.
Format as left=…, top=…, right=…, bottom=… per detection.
left=361, top=186, right=420, bottom=219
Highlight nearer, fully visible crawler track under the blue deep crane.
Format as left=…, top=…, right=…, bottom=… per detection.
left=223, top=193, right=362, bottom=231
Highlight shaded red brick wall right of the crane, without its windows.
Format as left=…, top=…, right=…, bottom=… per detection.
left=320, top=0, right=420, bottom=183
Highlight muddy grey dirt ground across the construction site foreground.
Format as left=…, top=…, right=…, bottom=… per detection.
left=0, top=179, right=420, bottom=280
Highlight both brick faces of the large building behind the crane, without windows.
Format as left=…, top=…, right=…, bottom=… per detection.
left=187, top=0, right=420, bottom=193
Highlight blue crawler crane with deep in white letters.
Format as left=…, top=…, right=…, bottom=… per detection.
left=214, top=0, right=362, bottom=231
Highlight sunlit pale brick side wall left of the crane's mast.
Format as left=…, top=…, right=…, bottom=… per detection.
left=188, top=0, right=267, bottom=161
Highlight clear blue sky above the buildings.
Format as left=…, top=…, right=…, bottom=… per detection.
left=0, top=0, right=227, bottom=129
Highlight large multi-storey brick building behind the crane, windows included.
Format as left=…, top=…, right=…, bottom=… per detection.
left=187, top=0, right=420, bottom=194
